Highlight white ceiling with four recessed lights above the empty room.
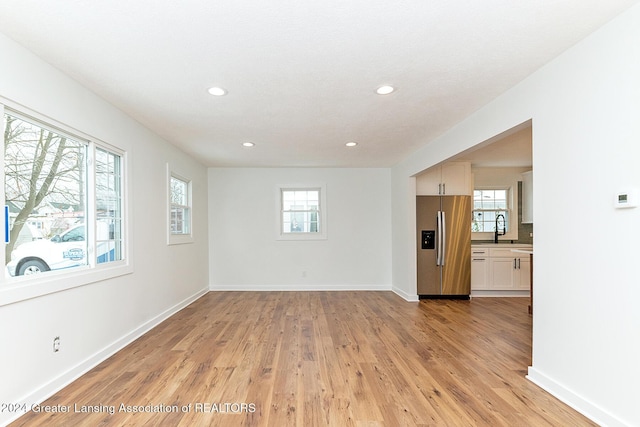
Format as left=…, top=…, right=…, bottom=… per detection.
left=0, top=0, right=638, bottom=167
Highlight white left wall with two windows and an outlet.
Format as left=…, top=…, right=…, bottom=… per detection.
left=0, top=35, right=208, bottom=425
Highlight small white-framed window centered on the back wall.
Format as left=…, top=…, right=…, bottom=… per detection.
left=279, top=186, right=327, bottom=240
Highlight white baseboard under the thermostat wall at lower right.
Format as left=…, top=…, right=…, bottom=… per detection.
left=526, top=366, right=631, bottom=427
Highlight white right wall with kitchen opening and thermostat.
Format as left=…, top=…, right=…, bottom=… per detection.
left=392, top=6, right=640, bottom=426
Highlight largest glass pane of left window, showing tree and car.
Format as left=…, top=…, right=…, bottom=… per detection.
left=4, top=114, right=87, bottom=275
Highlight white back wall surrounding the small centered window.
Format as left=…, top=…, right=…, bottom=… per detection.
left=209, top=168, right=391, bottom=290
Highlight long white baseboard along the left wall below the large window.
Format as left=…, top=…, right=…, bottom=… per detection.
left=5, top=289, right=209, bottom=426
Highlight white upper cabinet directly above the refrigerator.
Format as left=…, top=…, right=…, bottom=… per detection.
left=416, top=162, right=473, bottom=196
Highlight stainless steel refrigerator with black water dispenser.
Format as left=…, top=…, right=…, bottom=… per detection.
left=416, top=196, right=471, bottom=298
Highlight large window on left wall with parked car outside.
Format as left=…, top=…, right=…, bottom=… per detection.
left=4, top=110, right=124, bottom=277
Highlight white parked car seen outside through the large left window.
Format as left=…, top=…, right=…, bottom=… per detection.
left=7, top=224, right=87, bottom=276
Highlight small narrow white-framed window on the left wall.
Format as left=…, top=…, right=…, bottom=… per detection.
left=167, top=171, right=192, bottom=244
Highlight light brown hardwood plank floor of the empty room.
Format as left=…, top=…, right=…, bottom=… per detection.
left=12, top=292, right=595, bottom=427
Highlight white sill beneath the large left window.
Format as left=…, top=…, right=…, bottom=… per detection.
left=0, top=262, right=133, bottom=307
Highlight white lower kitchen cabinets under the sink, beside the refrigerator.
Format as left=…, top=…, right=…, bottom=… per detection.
left=471, top=248, right=531, bottom=291
